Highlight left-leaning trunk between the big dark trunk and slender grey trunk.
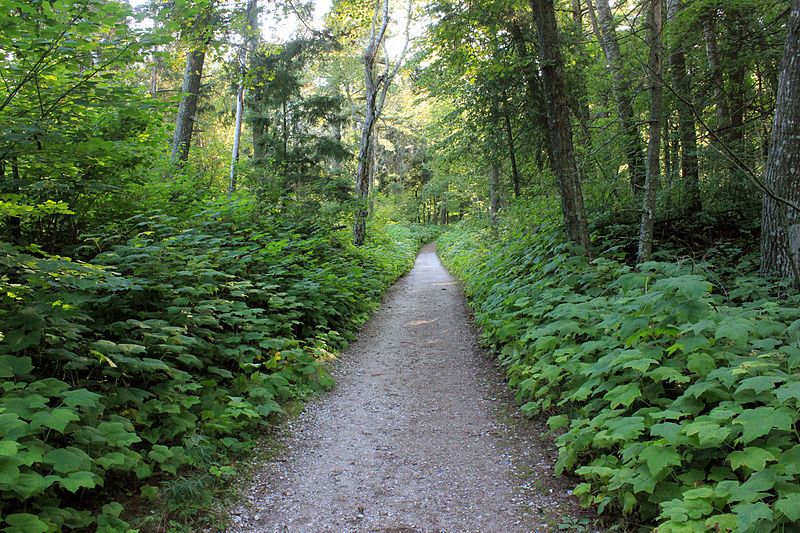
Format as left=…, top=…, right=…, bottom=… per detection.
left=587, top=0, right=645, bottom=192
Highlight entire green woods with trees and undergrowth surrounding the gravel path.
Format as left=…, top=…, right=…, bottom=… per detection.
left=0, top=0, right=800, bottom=532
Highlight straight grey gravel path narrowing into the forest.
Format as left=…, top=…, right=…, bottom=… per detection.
left=232, top=245, right=579, bottom=532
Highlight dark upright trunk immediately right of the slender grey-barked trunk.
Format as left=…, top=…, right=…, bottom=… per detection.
left=667, top=0, right=702, bottom=213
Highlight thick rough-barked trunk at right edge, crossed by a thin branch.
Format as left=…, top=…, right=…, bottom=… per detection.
left=761, top=0, right=800, bottom=283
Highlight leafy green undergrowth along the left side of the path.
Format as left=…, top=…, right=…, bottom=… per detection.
left=0, top=202, right=434, bottom=532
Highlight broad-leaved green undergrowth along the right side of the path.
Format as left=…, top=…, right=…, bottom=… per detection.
left=439, top=201, right=800, bottom=533
